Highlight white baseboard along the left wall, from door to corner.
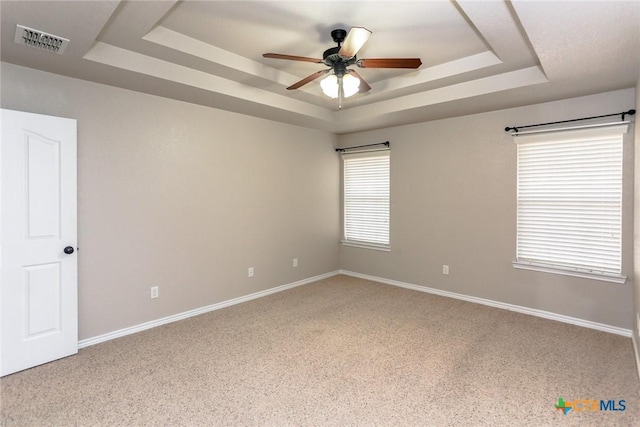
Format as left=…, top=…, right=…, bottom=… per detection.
left=78, top=271, right=339, bottom=349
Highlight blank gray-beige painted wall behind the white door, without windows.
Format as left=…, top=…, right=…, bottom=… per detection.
left=1, top=64, right=340, bottom=339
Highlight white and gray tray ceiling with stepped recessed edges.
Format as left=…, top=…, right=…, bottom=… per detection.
left=0, top=0, right=640, bottom=134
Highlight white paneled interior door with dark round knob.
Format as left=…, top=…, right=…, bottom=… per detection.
left=0, top=110, right=78, bottom=375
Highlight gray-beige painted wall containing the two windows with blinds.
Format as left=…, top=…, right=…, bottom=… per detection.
left=339, top=89, right=636, bottom=328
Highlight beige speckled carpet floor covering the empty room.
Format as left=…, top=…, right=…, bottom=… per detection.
left=1, top=276, right=640, bottom=426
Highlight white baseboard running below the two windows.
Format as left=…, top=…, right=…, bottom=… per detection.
left=339, top=270, right=638, bottom=338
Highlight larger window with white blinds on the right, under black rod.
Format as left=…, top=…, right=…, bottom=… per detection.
left=514, top=124, right=627, bottom=283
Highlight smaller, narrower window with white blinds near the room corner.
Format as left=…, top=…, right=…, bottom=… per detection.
left=342, top=150, right=390, bottom=250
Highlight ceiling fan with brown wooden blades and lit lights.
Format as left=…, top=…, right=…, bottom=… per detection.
left=262, top=27, right=422, bottom=108
